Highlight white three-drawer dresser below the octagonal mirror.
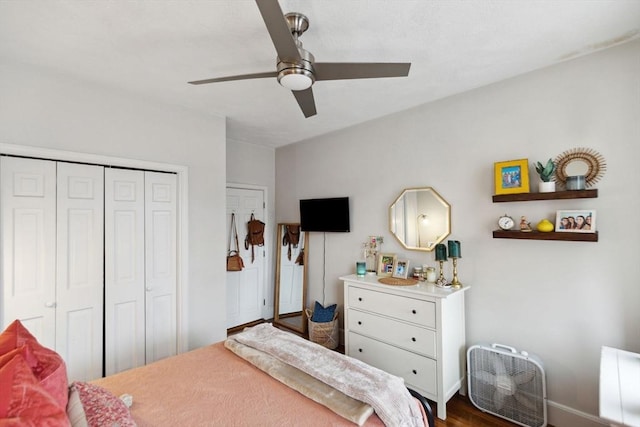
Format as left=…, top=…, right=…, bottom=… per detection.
left=340, top=275, right=469, bottom=420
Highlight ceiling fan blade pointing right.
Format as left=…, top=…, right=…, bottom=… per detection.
left=313, top=62, right=411, bottom=80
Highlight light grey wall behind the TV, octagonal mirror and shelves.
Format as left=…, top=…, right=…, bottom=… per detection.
left=276, top=41, right=640, bottom=427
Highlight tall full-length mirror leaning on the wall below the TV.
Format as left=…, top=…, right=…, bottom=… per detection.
left=273, top=223, right=309, bottom=334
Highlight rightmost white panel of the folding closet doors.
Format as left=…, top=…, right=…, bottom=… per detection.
left=145, top=172, right=177, bottom=363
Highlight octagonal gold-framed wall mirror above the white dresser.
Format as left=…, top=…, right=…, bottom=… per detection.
left=389, top=187, right=451, bottom=251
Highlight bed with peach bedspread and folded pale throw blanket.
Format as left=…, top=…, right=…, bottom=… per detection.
left=0, top=324, right=434, bottom=427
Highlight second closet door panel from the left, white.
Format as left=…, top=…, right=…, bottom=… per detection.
left=55, top=162, right=104, bottom=381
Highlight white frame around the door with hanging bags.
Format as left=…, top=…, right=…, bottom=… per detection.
left=225, top=182, right=275, bottom=319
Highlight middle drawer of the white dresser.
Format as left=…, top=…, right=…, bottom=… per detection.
left=347, top=309, right=436, bottom=358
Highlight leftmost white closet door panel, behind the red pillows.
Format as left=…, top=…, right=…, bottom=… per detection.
left=0, top=156, right=56, bottom=348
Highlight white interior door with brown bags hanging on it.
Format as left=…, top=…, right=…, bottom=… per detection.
left=226, top=188, right=269, bottom=328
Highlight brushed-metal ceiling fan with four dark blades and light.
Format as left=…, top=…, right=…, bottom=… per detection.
left=189, top=0, right=411, bottom=117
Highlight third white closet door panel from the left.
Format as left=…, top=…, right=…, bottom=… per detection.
left=105, top=169, right=145, bottom=375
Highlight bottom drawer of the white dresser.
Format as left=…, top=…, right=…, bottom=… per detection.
left=346, top=332, right=438, bottom=399
